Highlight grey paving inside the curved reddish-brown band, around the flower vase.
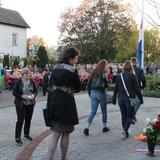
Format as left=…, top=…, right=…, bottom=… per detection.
left=31, top=106, right=160, bottom=160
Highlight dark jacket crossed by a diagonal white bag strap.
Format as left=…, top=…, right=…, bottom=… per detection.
left=112, top=72, right=143, bottom=104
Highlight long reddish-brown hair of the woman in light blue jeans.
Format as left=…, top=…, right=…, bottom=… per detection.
left=90, top=59, right=108, bottom=77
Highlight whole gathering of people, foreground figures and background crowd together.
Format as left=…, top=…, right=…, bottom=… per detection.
left=0, top=48, right=159, bottom=160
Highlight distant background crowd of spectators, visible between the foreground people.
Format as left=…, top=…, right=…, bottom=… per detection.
left=1, top=59, right=158, bottom=95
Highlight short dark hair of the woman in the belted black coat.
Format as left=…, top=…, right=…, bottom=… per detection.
left=60, top=48, right=80, bottom=64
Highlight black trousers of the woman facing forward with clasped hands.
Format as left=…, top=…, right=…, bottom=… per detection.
left=15, top=105, right=34, bottom=139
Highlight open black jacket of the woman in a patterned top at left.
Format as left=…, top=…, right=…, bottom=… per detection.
left=13, top=79, right=38, bottom=107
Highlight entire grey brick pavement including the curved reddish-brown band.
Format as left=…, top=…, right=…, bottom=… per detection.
left=0, top=94, right=160, bottom=160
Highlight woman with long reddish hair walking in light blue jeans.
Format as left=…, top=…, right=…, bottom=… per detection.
left=83, top=59, right=109, bottom=136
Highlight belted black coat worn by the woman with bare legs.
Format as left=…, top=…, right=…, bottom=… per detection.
left=47, top=64, right=81, bottom=125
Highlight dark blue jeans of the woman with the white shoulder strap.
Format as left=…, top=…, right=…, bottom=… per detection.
left=118, top=97, right=133, bottom=131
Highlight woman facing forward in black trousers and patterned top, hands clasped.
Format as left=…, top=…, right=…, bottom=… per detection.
left=13, top=68, right=37, bottom=145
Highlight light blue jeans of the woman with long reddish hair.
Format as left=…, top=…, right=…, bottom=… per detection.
left=88, top=90, right=107, bottom=125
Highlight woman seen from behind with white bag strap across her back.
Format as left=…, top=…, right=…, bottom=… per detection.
left=112, top=60, right=143, bottom=140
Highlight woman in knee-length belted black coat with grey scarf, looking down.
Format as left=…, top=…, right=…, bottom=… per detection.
left=47, top=48, right=80, bottom=160
